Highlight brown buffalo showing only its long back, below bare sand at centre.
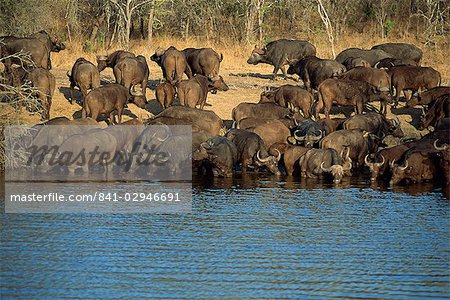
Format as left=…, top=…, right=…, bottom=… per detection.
left=231, top=102, right=291, bottom=122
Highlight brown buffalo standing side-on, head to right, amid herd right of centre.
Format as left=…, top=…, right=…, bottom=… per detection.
left=315, top=78, right=382, bottom=119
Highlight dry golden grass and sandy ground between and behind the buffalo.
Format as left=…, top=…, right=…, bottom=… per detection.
left=7, top=34, right=450, bottom=124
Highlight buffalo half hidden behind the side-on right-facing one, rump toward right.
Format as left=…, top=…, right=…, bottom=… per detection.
left=338, top=67, right=391, bottom=114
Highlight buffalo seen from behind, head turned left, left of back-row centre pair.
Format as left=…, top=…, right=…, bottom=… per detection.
left=150, top=46, right=192, bottom=85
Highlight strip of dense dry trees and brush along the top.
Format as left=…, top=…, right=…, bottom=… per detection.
left=0, top=0, right=449, bottom=51
